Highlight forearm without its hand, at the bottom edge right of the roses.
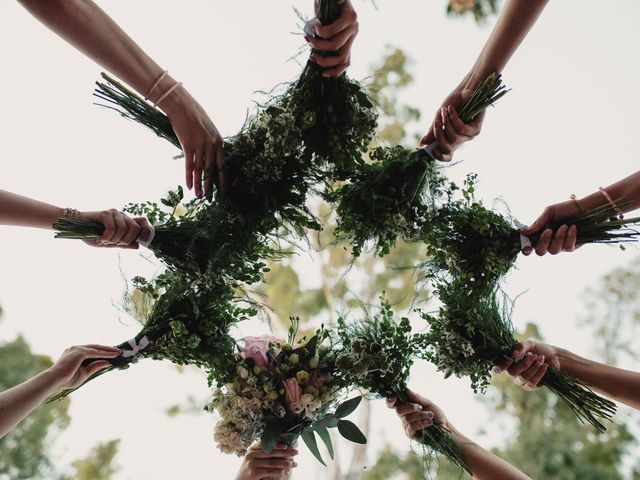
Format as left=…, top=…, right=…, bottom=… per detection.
left=451, top=428, right=531, bottom=480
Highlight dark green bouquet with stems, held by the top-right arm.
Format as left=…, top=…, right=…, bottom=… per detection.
left=328, top=73, right=507, bottom=256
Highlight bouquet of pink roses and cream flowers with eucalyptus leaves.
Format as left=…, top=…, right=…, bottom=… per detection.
left=207, top=319, right=366, bottom=464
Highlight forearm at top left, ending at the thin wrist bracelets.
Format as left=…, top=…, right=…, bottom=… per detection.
left=20, top=0, right=169, bottom=99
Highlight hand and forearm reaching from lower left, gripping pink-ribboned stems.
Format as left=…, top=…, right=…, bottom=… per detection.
left=0, top=345, right=122, bottom=438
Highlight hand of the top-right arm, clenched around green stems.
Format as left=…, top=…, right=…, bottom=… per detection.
left=420, top=87, right=485, bottom=162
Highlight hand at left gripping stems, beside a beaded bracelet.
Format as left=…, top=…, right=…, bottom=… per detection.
left=80, top=209, right=152, bottom=249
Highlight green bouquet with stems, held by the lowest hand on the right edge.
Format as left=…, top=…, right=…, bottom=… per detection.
left=418, top=280, right=616, bottom=431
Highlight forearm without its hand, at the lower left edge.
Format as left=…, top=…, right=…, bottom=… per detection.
left=0, top=370, right=59, bottom=438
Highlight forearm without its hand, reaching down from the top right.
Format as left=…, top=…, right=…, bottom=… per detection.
left=463, top=0, right=548, bottom=90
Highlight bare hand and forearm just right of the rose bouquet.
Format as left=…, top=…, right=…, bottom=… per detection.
left=387, top=390, right=531, bottom=480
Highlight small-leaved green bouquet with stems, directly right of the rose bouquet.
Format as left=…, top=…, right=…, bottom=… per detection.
left=336, top=299, right=468, bottom=471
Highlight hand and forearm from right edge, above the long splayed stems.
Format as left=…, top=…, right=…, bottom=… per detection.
left=500, top=339, right=640, bottom=409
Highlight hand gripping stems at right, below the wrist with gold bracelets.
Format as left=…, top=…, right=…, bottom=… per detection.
left=522, top=200, right=582, bottom=256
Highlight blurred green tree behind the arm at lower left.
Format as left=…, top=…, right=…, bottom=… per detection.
left=0, top=337, right=69, bottom=480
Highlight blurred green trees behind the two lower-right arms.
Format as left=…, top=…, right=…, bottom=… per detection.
left=365, top=324, right=637, bottom=480
